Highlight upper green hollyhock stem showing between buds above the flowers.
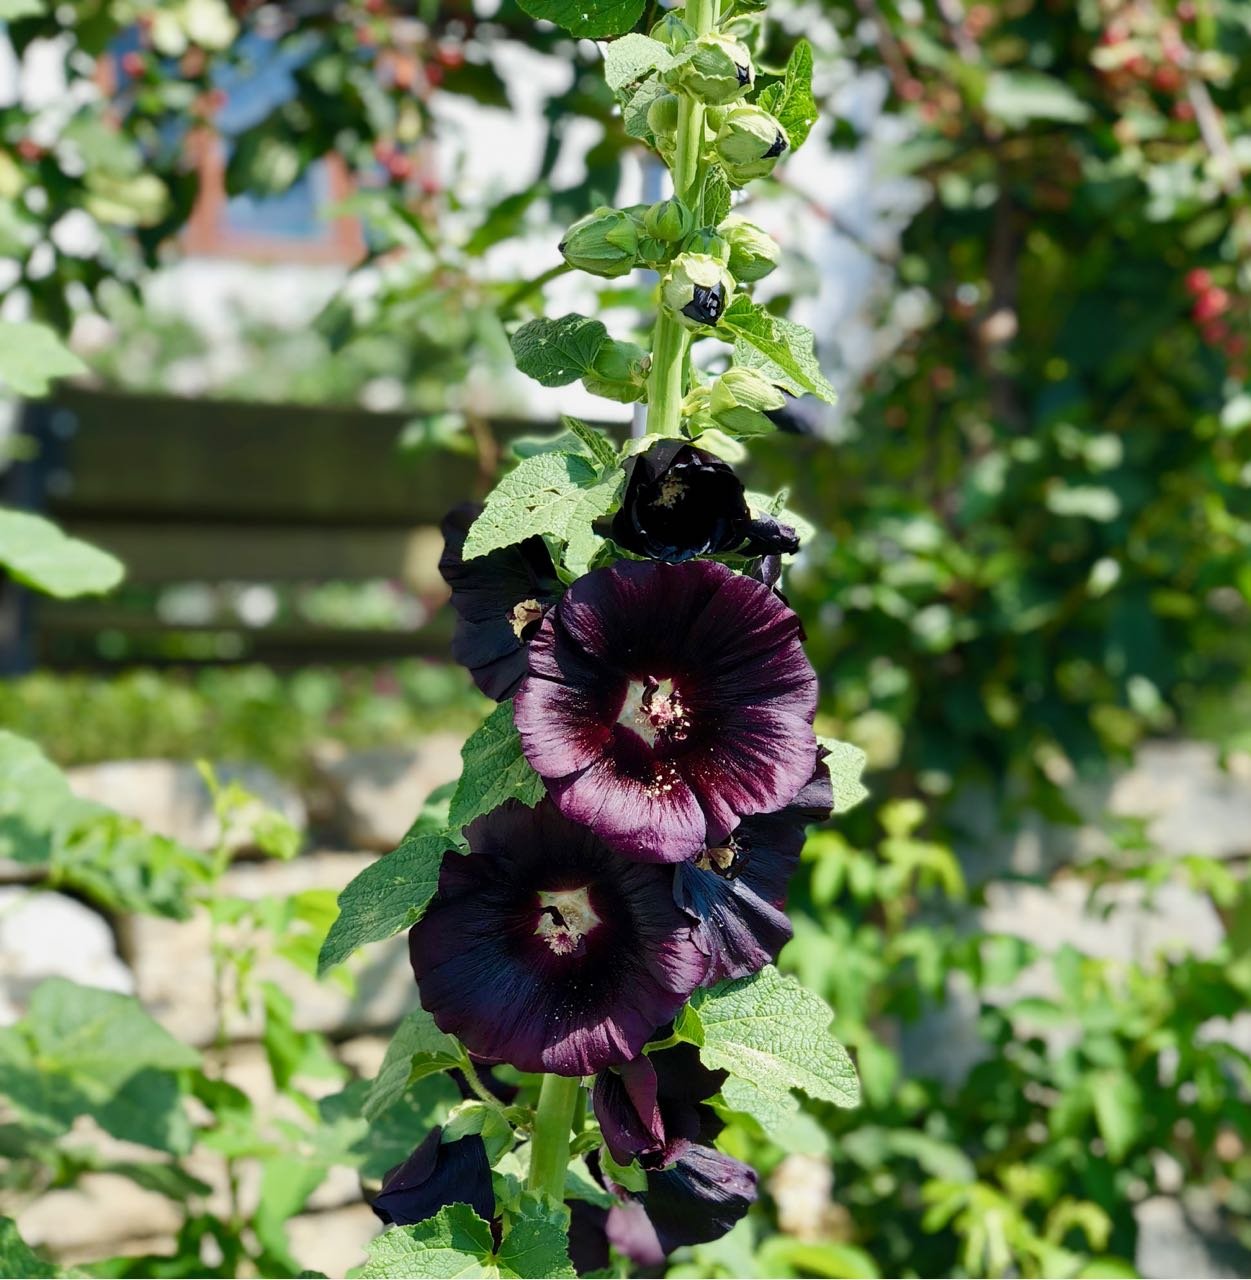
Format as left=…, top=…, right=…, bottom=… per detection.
left=647, top=0, right=720, bottom=435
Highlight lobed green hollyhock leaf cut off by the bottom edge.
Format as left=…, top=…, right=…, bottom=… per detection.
left=360, top=1194, right=576, bottom=1280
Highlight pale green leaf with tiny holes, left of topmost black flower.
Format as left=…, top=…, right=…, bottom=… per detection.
left=465, top=453, right=599, bottom=559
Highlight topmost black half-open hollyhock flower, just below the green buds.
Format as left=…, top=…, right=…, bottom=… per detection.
left=604, top=440, right=799, bottom=562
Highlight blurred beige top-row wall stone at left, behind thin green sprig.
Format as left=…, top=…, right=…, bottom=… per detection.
left=65, top=760, right=309, bottom=851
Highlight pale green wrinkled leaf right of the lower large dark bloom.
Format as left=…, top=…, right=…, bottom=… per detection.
left=680, top=965, right=860, bottom=1107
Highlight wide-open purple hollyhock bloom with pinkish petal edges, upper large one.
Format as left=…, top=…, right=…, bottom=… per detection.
left=516, top=561, right=817, bottom=863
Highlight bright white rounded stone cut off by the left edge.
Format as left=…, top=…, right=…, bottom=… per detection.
left=0, top=887, right=134, bottom=1025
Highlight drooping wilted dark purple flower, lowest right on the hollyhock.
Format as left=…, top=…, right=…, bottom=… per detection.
left=570, top=1143, right=757, bottom=1274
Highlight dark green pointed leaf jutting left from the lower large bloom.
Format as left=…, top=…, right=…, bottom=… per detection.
left=318, top=832, right=455, bottom=974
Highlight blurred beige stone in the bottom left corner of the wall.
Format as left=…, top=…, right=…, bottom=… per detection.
left=17, top=1174, right=182, bottom=1257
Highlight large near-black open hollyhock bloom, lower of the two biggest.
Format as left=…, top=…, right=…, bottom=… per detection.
left=408, top=800, right=708, bottom=1075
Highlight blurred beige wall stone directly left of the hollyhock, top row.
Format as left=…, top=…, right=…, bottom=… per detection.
left=316, top=733, right=465, bottom=851
